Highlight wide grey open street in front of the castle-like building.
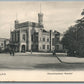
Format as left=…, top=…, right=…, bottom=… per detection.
left=0, top=53, right=84, bottom=71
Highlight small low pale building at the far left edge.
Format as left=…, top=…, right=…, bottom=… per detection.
left=0, top=38, right=10, bottom=52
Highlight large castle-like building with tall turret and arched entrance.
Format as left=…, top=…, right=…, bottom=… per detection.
left=10, top=13, right=60, bottom=52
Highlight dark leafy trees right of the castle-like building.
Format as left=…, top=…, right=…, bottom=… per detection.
left=62, top=10, right=84, bottom=56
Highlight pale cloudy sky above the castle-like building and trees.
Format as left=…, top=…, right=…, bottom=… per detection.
left=0, top=1, right=84, bottom=38
